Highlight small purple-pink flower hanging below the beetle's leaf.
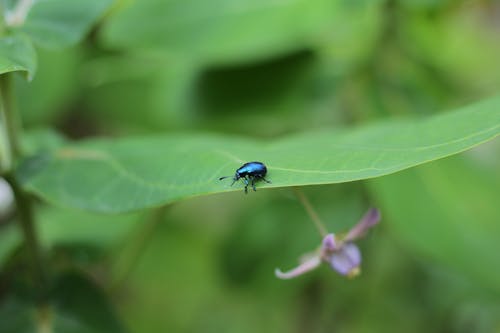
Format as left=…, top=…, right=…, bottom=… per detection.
left=275, top=208, right=380, bottom=279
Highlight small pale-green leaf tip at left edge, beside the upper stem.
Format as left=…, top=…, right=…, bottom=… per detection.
left=0, top=34, right=36, bottom=80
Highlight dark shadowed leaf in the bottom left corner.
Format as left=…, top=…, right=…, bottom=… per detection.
left=0, top=273, right=123, bottom=333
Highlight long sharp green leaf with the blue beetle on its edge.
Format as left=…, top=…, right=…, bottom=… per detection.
left=20, top=97, right=500, bottom=213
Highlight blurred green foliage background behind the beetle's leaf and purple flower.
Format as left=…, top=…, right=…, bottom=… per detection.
left=0, top=0, right=500, bottom=333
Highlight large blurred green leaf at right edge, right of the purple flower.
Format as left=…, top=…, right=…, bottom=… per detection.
left=370, top=152, right=500, bottom=292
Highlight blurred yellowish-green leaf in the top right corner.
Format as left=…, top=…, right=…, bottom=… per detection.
left=401, top=1, right=500, bottom=94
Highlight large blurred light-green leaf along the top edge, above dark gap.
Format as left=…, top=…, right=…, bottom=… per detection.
left=102, top=0, right=336, bottom=63
